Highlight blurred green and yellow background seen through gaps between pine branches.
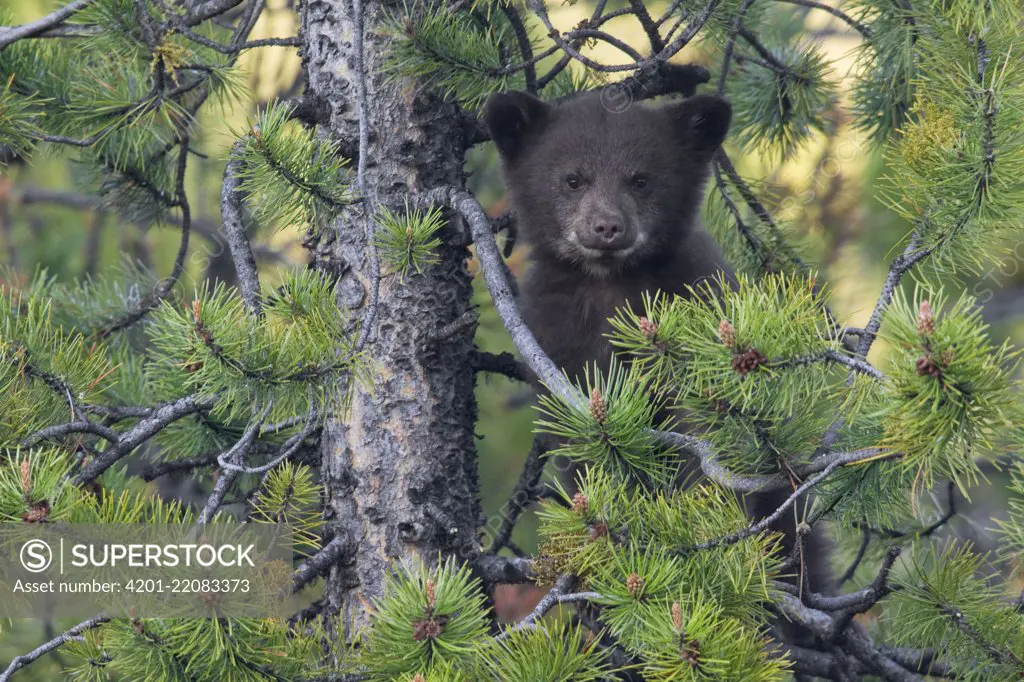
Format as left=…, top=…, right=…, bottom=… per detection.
left=0, top=0, right=1024, bottom=681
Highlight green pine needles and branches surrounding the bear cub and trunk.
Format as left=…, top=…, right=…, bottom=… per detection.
left=0, top=0, right=1024, bottom=682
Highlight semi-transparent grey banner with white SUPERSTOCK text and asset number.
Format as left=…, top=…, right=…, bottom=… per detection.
left=0, top=523, right=305, bottom=619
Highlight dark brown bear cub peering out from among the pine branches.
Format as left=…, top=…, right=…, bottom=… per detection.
left=484, top=92, right=826, bottom=591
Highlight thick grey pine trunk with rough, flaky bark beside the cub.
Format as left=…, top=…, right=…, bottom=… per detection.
left=302, top=0, right=481, bottom=634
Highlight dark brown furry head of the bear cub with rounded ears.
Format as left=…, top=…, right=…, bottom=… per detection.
left=484, top=92, right=732, bottom=276
